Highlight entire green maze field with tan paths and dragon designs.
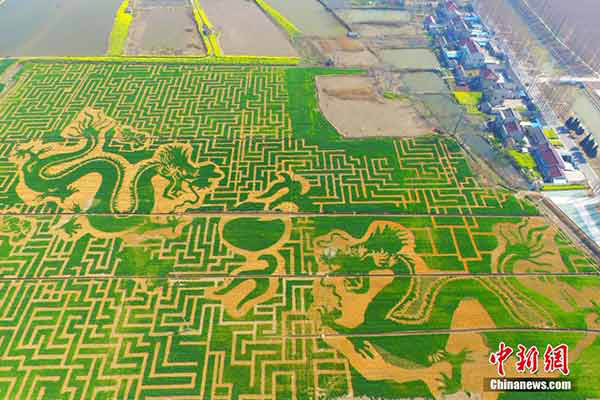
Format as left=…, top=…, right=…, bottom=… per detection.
left=0, top=63, right=600, bottom=400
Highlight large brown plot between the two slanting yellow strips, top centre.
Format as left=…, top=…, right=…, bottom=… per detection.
left=200, top=0, right=298, bottom=57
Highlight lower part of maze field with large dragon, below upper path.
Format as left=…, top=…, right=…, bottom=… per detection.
left=0, top=214, right=600, bottom=400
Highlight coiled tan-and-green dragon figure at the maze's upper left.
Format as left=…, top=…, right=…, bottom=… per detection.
left=11, top=109, right=224, bottom=238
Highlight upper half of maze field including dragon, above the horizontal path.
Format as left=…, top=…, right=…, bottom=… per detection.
left=0, top=64, right=536, bottom=215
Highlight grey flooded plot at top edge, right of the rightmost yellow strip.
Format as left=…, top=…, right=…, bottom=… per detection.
left=269, top=0, right=346, bottom=38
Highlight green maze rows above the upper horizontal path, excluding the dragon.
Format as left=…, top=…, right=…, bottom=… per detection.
left=0, top=64, right=536, bottom=215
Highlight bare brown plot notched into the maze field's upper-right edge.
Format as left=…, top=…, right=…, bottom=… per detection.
left=317, top=76, right=432, bottom=137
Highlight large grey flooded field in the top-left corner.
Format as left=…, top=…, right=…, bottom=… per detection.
left=0, top=0, right=121, bottom=56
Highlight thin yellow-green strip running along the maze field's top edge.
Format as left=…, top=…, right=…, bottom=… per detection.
left=20, top=55, right=300, bottom=65
